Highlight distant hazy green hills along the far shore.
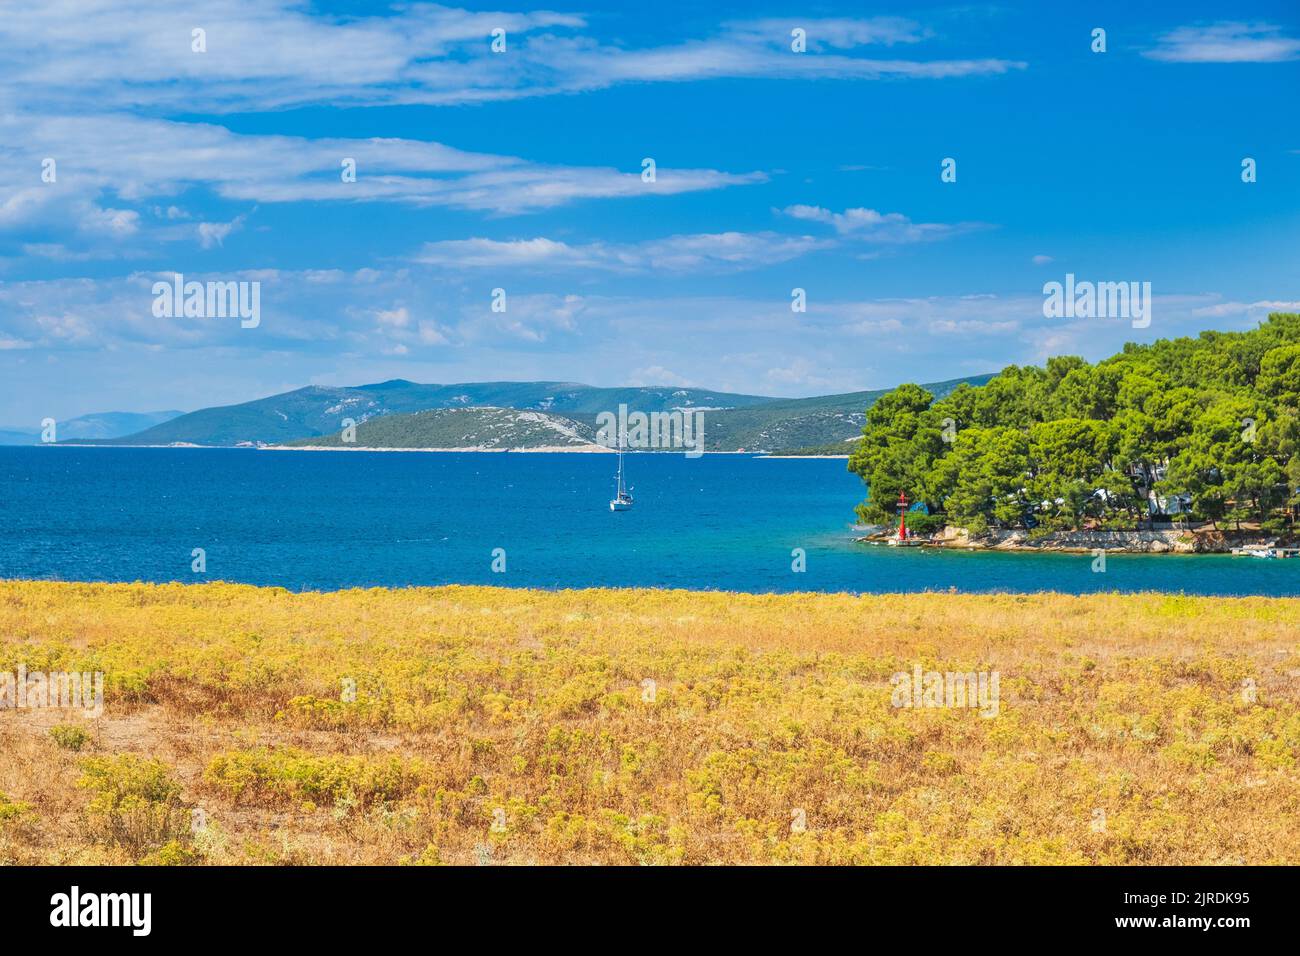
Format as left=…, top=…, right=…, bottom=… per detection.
left=21, top=375, right=991, bottom=454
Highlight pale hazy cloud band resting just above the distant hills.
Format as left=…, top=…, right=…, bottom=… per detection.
left=0, top=269, right=1300, bottom=420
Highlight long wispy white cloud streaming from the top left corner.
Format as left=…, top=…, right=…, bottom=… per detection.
left=0, top=0, right=1024, bottom=112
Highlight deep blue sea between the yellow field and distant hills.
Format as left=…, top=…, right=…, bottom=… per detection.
left=0, top=447, right=1300, bottom=594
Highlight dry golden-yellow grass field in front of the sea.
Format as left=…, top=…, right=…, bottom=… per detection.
left=0, top=581, right=1300, bottom=864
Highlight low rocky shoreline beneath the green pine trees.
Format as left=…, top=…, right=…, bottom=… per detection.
left=857, top=527, right=1294, bottom=554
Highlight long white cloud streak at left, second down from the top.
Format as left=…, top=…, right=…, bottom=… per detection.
left=0, top=113, right=767, bottom=247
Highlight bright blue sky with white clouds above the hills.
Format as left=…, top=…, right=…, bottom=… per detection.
left=0, top=0, right=1300, bottom=425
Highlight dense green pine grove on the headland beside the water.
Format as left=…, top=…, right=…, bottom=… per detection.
left=849, top=312, right=1300, bottom=550
